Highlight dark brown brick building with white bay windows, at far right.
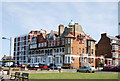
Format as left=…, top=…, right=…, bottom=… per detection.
left=96, top=33, right=120, bottom=65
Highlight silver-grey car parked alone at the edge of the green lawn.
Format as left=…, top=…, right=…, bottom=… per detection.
left=77, top=66, right=96, bottom=73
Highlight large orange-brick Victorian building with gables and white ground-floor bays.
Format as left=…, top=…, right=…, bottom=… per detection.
left=28, top=21, right=95, bottom=68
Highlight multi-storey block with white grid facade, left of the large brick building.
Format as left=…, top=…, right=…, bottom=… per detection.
left=14, top=31, right=39, bottom=65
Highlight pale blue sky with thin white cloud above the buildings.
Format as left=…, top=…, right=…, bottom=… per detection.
left=0, top=2, right=118, bottom=58
